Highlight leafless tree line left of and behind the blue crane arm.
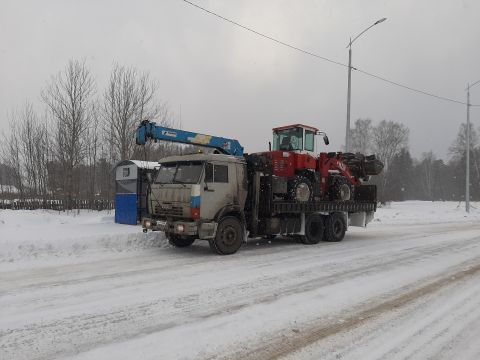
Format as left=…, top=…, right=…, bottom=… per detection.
left=0, top=60, right=186, bottom=208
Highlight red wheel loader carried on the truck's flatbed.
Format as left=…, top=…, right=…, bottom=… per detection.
left=263, top=124, right=383, bottom=202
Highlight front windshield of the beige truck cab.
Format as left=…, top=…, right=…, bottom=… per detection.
left=155, top=161, right=203, bottom=184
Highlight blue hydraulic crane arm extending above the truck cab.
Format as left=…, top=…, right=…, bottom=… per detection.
left=136, top=120, right=243, bottom=156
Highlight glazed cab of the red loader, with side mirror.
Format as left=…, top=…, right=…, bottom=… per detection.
left=272, top=124, right=328, bottom=155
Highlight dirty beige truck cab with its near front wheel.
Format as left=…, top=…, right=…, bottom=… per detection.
left=143, top=154, right=248, bottom=253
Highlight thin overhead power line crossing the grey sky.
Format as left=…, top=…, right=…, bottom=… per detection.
left=182, top=0, right=480, bottom=106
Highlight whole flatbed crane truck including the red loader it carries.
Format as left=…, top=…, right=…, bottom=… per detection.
left=136, top=121, right=383, bottom=255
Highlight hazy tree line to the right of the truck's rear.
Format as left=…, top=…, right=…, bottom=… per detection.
left=351, top=119, right=480, bottom=202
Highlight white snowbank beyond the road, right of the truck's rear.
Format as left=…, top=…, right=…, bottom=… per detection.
left=373, top=201, right=480, bottom=224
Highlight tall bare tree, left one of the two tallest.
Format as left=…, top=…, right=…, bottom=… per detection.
left=42, top=60, right=95, bottom=208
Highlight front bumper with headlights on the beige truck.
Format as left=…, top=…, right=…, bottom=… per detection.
left=142, top=218, right=218, bottom=239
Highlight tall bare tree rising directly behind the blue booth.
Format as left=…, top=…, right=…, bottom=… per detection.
left=103, top=64, right=163, bottom=161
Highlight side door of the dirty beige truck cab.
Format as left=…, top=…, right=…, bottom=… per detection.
left=200, top=161, right=237, bottom=220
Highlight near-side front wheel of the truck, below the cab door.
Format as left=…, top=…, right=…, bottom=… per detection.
left=209, top=216, right=244, bottom=255
